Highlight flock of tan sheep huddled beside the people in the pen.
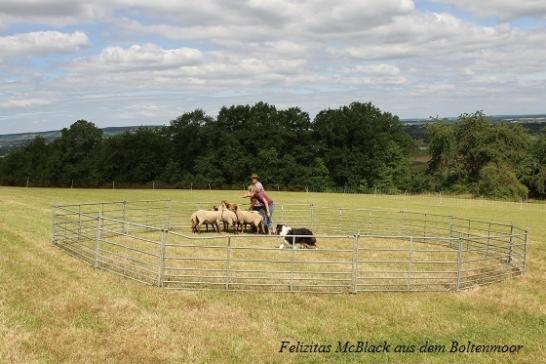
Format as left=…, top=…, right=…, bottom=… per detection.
left=191, top=201, right=266, bottom=234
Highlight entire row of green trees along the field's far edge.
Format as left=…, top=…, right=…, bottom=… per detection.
left=0, top=102, right=546, bottom=199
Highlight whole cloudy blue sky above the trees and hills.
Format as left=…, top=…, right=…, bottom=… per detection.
left=0, top=0, right=546, bottom=134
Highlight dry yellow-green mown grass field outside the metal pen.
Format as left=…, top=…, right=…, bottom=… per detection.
left=0, top=188, right=546, bottom=363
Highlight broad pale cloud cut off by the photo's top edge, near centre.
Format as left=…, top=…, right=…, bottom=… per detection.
left=118, top=0, right=414, bottom=43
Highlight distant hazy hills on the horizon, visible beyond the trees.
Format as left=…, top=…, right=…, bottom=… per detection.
left=0, top=114, right=546, bottom=156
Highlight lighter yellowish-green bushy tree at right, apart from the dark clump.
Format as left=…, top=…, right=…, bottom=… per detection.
left=427, top=111, right=540, bottom=199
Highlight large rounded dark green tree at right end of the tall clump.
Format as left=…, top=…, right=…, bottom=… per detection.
left=313, top=102, right=414, bottom=191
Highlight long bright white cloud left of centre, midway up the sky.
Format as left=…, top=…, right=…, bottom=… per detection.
left=63, top=44, right=314, bottom=89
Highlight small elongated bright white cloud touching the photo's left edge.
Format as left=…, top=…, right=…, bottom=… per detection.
left=0, top=31, right=89, bottom=58
